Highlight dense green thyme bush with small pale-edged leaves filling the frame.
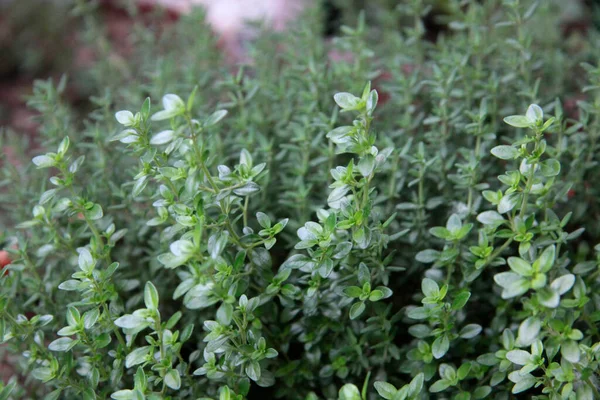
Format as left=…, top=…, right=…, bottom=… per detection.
left=0, top=0, right=600, bottom=400
